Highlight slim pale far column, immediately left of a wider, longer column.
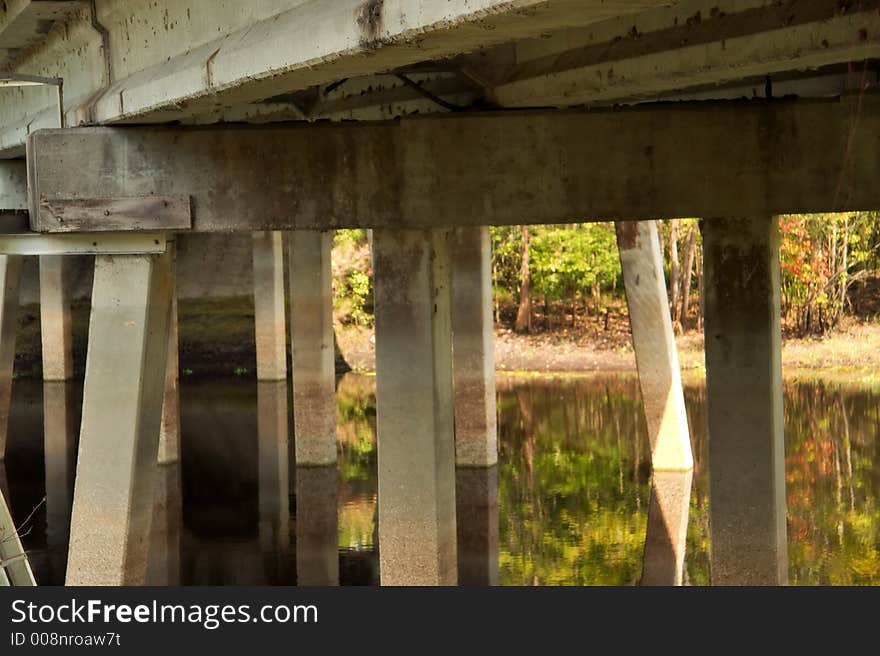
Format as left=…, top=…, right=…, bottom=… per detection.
left=254, top=232, right=287, bottom=380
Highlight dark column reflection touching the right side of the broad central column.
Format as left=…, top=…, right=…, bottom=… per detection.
left=455, top=466, right=498, bottom=586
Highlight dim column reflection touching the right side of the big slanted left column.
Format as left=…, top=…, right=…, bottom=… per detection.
left=146, top=462, right=183, bottom=586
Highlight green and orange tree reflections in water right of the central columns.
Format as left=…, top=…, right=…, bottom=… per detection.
left=498, top=377, right=880, bottom=585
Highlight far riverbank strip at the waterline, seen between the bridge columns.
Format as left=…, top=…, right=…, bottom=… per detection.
left=15, top=297, right=880, bottom=378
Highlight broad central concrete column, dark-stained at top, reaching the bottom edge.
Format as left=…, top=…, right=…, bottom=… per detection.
left=373, top=230, right=458, bottom=585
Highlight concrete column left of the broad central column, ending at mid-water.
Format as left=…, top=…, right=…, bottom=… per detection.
left=290, top=230, right=336, bottom=466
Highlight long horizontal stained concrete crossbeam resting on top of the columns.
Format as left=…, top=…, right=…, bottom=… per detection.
left=28, top=95, right=880, bottom=232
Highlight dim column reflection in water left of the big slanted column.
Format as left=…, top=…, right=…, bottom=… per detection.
left=43, top=381, right=79, bottom=581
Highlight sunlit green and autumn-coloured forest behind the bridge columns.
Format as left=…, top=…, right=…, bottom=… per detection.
left=333, top=212, right=880, bottom=336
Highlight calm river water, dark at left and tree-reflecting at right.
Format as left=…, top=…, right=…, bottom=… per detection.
left=0, top=375, right=880, bottom=585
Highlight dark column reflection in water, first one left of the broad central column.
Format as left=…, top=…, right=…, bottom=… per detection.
left=296, top=467, right=339, bottom=586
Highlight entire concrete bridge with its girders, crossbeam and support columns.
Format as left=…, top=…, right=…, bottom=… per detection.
left=0, top=0, right=880, bottom=584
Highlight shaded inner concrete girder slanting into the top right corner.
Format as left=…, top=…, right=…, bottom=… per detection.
left=488, top=0, right=880, bottom=107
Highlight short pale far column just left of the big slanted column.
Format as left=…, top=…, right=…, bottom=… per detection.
left=40, top=255, right=73, bottom=380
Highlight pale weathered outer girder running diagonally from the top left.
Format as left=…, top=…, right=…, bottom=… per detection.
left=0, top=0, right=670, bottom=144
